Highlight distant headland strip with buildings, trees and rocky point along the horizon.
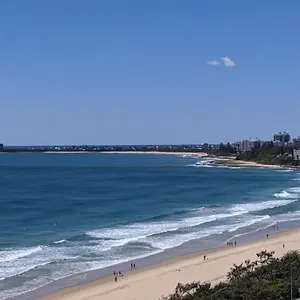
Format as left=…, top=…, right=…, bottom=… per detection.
left=0, top=132, right=300, bottom=168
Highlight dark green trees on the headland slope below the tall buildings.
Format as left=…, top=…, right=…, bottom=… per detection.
left=236, top=142, right=299, bottom=166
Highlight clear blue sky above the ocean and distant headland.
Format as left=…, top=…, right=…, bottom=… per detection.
left=0, top=0, right=300, bottom=145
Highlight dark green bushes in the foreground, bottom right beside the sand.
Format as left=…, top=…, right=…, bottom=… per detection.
left=162, top=251, right=300, bottom=300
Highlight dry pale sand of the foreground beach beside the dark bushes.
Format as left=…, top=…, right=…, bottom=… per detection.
left=40, top=229, right=300, bottom=300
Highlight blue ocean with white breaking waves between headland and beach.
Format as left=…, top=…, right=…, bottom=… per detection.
left=0, top=153, right=300, bottom=299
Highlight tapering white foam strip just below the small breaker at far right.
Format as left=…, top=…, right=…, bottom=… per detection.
left=230, top=200, right=297, bottom=213
